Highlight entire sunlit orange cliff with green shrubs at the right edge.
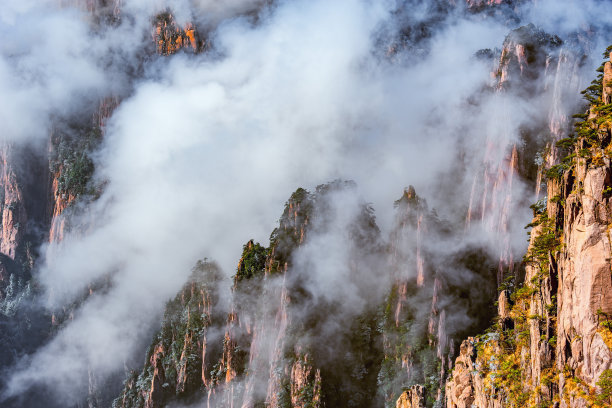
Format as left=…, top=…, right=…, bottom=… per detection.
left=447, top=44, right=612, bottom=408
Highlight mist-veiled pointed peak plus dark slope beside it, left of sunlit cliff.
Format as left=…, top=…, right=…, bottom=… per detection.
left=379, top=188, right=502, bottom=407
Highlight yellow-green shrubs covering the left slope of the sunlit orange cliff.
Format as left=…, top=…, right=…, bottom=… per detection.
left=476, top=203, right=565, bottom=407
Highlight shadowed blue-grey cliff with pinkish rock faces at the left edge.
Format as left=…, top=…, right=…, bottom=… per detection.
left=0, top=92, right=118, bottom=299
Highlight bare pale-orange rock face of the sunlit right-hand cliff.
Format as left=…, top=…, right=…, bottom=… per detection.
left=557, top=157, right=612, bottom=404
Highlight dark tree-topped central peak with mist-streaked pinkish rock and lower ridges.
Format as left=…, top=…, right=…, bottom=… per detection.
left=114, top=182, right=382, bottom=408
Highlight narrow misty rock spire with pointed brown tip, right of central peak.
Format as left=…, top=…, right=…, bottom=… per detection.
left=378, top=190, right=449, bottom=407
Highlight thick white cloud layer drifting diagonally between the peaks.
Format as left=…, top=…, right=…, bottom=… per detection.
left=0, top=0, right=612, bottom=402
